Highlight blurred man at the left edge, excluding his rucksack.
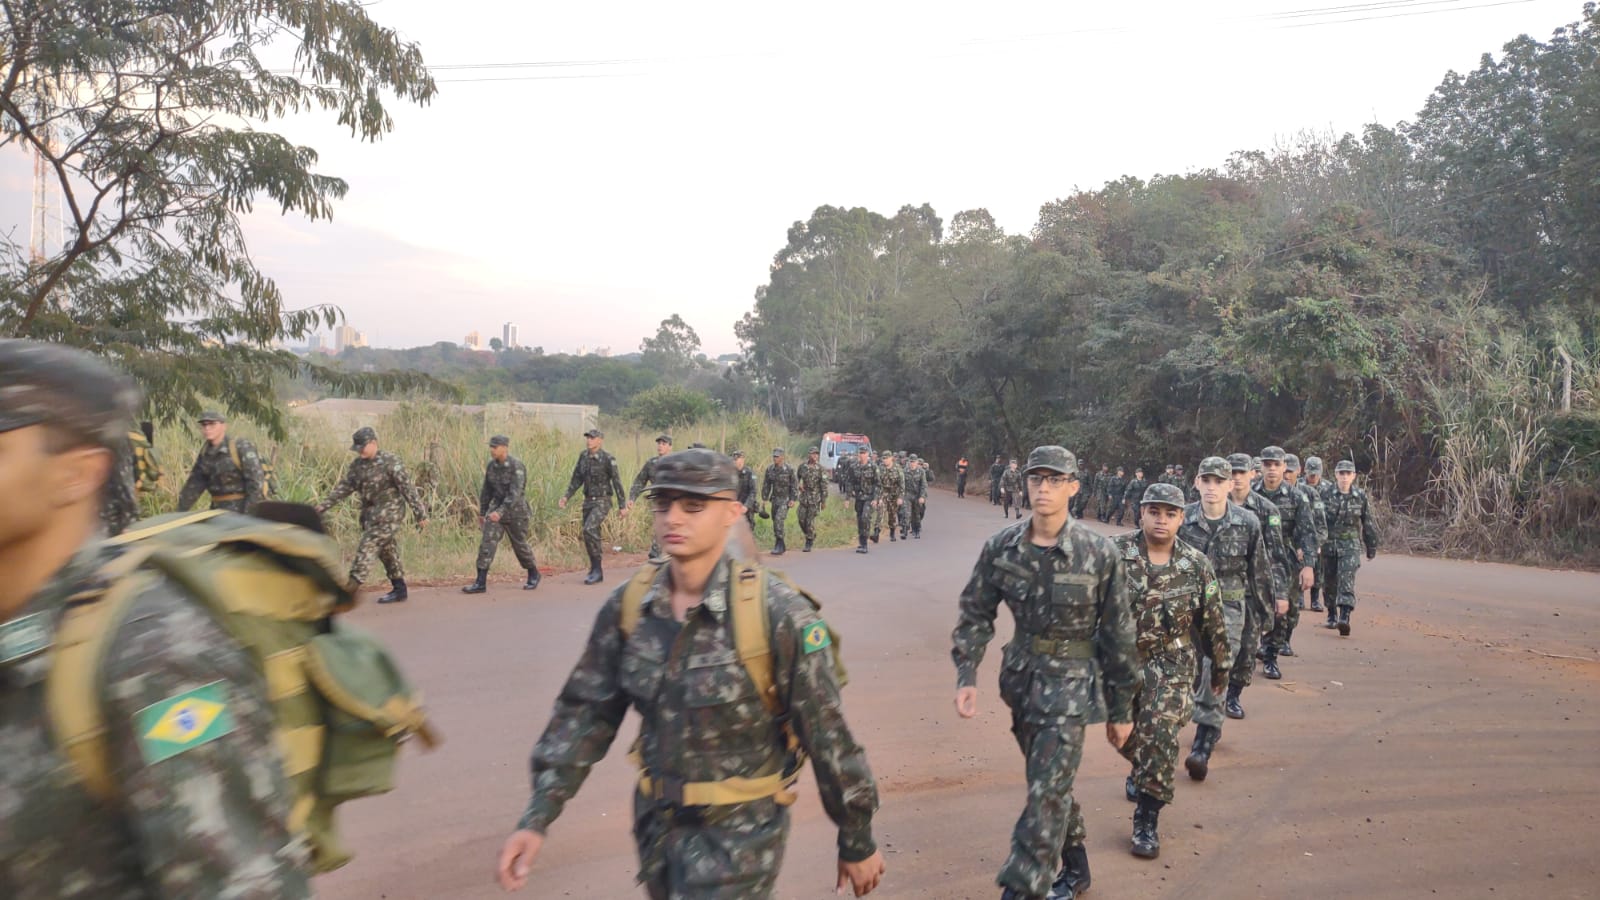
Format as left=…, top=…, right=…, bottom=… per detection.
left=0, top=341, right=312, bottom=900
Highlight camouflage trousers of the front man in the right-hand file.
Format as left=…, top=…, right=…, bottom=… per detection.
left=995, top=709, right=1086, bottom=897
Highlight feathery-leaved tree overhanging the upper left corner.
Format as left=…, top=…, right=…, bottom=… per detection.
left=0, top=0, right=435, bottom=434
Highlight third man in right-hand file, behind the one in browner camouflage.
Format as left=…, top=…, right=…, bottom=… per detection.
left=1178, top=456, right=1275, bottom=781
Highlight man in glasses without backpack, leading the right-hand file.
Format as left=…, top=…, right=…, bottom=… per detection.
left=950, top=447, right=1139, bottom=898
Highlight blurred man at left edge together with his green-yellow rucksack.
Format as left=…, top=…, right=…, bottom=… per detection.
left=0, top=341, right=429, bottom=900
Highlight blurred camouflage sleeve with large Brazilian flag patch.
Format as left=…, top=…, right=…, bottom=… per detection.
left=102, top=583, right=312, bottom=900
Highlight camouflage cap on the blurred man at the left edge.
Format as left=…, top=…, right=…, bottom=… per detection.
left=0, top=340, right=139, bottom=447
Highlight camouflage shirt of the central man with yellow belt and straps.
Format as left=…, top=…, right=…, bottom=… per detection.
left=517, top=557, right=878, bottom=897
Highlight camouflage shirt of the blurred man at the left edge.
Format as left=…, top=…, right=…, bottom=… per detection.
left=0, top=552, right=312, bottom=900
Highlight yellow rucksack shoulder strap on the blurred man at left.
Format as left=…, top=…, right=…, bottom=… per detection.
left=45, top=538, right=165, bottom=802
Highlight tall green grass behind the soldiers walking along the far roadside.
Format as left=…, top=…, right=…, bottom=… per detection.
left=142, top=402, right=854, bottom=583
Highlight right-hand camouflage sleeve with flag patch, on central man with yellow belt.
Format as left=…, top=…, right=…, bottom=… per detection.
left=766, top=577, right=878, bottom=863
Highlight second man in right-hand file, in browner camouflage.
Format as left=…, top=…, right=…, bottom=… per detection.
left=1117, top=484, right=1232, bottom=860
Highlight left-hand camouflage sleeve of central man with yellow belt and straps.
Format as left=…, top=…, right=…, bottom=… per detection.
left=517, top=588, right=629, bottom=834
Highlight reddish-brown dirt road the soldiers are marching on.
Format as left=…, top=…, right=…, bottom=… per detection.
left=320, top=492, right=1600, bottom=900
